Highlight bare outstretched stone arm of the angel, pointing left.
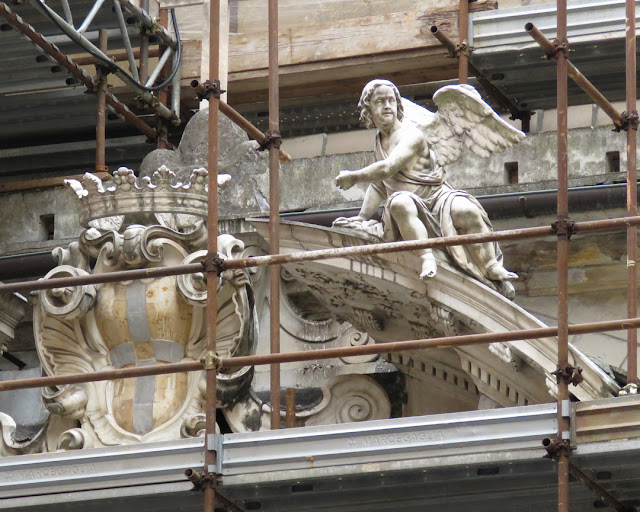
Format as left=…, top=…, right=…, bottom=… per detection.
left=336, top=127, right=427, bottom=190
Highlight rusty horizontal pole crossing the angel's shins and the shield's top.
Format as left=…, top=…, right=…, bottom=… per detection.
left=0, top=216, right=640, bottom=293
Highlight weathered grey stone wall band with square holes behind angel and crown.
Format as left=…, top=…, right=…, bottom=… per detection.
left=0, top=123, right=626, bottom=255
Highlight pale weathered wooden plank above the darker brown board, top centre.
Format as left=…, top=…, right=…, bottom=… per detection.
left=229, top=0, right=496, bottom=73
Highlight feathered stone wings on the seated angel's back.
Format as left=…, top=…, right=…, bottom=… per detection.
left=402, top=84, right=524, bottom=166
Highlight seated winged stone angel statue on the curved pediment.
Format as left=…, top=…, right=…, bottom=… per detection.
left=333, top=79, right=524, bottom=298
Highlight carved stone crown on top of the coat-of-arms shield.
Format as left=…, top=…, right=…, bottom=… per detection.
left=65, top=165, right=231, bottom=227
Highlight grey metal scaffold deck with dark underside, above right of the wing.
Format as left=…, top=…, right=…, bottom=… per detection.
left=470, top=0, right=640, bottom=110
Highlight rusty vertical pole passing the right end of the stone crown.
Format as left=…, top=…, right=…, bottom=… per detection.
left=204, top=0, right=220, bottom=512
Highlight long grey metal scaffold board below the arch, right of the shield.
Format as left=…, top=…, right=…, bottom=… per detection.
left=220, top=404, right=557, bottom=486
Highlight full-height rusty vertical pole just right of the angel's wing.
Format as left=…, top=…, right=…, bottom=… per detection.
left=556, top=0, right=569, bottom=512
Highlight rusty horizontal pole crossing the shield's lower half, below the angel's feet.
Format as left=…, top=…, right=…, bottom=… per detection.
left=0, top=318, right=640, bottom=391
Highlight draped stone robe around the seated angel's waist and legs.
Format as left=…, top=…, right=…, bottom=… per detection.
left=362, top=134, right=502, bottom=285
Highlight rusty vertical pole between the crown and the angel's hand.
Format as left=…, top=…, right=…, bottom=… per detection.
left=268, top=0, right=280, bottom=429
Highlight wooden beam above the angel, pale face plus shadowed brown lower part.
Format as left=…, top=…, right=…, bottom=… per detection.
left=178, top=0, right=497, bottom=105
